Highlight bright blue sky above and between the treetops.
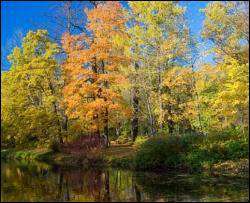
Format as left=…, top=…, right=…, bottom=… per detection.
left=1, top=1, right=212, bottom=71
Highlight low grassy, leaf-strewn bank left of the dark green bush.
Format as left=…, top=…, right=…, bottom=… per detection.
left=1, top=145, right=136, bottom=169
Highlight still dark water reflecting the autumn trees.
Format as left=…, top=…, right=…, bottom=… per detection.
left=1, top=161, right=249, bottom=202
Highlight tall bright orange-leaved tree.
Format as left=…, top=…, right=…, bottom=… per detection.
left=62, top=2, right=130, bottom=146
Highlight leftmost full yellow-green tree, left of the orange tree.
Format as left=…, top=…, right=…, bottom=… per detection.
left=1, top=30, right=61, bottom=144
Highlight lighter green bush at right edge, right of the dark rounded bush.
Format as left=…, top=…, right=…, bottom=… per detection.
left=185, top=129, right=249, bottom=169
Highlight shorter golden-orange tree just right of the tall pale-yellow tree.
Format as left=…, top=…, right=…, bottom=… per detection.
left=162, top=67, right=197, bottom=134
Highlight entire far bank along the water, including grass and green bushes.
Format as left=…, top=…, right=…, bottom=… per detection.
left=1, top=130, right=249, bottom=176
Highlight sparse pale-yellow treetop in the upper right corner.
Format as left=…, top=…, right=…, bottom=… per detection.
left=202, top=1, right=249, bottom=63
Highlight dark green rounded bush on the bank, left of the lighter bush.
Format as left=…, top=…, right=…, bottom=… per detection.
left=135, top=136, right=188, bottom=169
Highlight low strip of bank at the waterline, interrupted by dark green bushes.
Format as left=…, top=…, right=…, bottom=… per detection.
left=1, top=145, right=249, bottom=177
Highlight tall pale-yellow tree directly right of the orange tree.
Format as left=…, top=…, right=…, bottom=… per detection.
left=118, top=2, right=189, bottom=136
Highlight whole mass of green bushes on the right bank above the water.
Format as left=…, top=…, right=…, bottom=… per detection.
left=135, top=129, right=249, bottom=170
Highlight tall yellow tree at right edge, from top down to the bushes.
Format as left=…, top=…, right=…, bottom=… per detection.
left=200, top=2, right=249, bottom=132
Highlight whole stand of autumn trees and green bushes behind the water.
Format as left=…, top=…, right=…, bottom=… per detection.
left=1, top=1, right=249, bottom=173
